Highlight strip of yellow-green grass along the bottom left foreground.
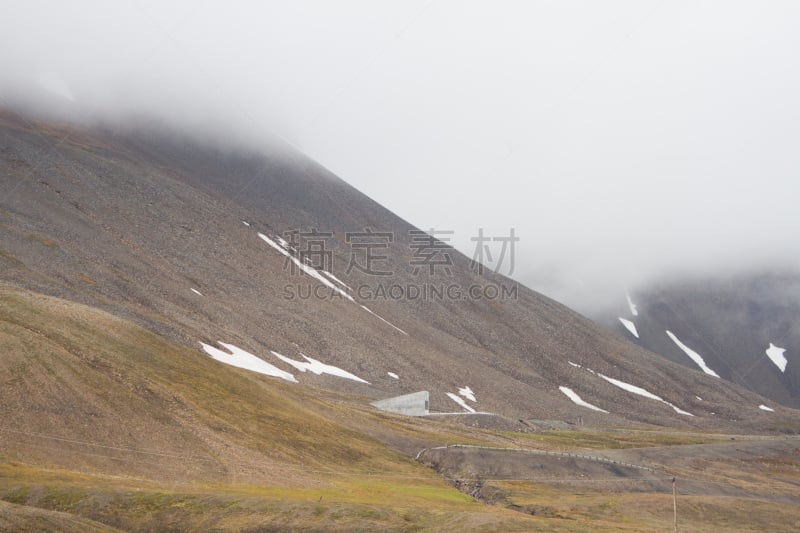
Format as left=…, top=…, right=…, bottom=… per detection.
left=0, top=464, right=531, bottom=531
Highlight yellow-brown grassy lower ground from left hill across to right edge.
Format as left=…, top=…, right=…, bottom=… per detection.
left=0, top=285, right=800, bottom=531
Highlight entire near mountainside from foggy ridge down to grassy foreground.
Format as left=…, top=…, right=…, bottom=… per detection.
left=0, top=108, right=800, bottom=531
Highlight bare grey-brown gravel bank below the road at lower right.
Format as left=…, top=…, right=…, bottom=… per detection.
left=419, top=437, right=800, bottom=504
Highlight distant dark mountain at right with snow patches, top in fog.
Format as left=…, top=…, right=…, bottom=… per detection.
left=596, top=271, right=800, bottom=408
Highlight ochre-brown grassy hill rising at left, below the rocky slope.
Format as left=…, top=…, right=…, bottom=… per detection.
left=0, top=287, right=540, bottom=530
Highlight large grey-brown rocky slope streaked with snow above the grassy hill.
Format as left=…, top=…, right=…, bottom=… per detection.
left=0, top=107, right=795, bottom=428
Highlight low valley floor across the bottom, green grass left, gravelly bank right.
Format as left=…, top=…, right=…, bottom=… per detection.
left=0, top=430, right=800, bottom=531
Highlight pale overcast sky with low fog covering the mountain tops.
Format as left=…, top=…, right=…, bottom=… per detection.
left=0, top=0, right=800, bottom=307
